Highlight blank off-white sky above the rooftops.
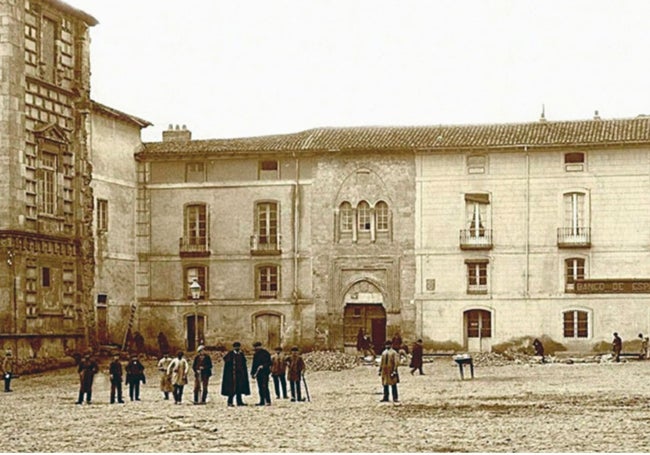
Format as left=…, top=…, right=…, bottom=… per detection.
left=65, top=0, right=650, bottom=141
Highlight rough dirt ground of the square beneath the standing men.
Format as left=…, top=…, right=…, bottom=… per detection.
left=0, top=358, right=650, bottom=452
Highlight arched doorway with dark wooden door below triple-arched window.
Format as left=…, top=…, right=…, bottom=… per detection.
left=343, top=281, right=386, bottom=354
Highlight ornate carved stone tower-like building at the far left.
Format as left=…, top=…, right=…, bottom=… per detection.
left=0, top=0, right=97, bottom=357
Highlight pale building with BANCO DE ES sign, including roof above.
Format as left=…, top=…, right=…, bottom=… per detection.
left=415, top=115, right=650, bottom=351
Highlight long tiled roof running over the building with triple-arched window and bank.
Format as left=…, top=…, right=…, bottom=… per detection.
left=141, top=116, right=650, bottom=155
